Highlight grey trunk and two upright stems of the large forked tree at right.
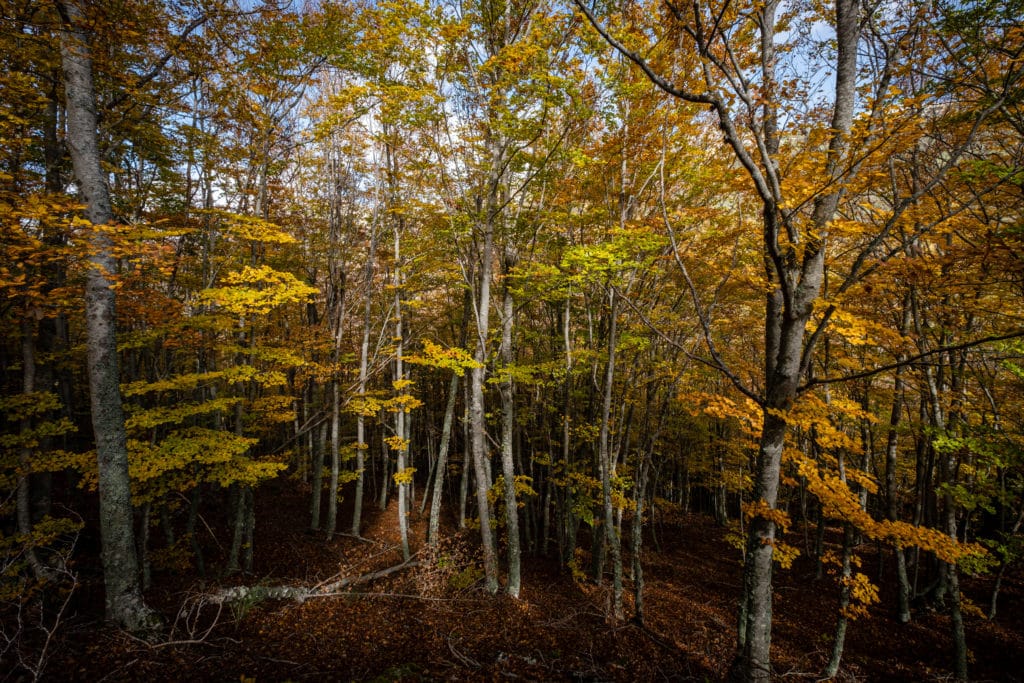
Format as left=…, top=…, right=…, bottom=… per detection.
left=730, top=0, right=860, bottom=681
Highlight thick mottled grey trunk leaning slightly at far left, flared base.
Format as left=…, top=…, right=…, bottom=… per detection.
left=57, top=0, right=161, bottom=631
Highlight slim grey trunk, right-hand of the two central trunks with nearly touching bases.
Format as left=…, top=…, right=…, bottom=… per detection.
left=498, top=246, right=522, bottom=598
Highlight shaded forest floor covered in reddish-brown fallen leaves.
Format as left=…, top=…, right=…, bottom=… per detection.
left=32, top=479, right=1024, bottom=682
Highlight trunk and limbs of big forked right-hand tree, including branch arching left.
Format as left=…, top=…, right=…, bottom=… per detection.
left=573, top=0, right=861, bottom=681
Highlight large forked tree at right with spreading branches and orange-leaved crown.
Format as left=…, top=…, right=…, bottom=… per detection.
left=577, top=0, right=1024, bottom=680
